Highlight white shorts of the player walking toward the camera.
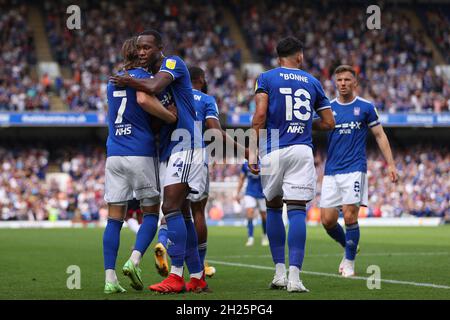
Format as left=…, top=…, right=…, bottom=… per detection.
left=320, top=172, right=369, bottom=208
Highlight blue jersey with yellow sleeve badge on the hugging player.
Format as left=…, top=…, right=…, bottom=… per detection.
left=159, top=56, right=204, bottom=154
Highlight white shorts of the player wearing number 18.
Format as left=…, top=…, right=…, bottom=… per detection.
left=260, top=144, right=317, bottom=201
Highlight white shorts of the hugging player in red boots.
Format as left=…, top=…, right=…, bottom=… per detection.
left=159, top=148, right=208, bottom=201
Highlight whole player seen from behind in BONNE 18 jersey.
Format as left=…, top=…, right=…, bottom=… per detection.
left=249, top=37, right=334, bottom=292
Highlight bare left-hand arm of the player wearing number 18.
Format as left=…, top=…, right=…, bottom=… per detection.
left=248, top=92, right=269, bottom=174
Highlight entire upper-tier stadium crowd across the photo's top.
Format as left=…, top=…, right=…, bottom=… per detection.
left=0, top=0, right=450, bottom=114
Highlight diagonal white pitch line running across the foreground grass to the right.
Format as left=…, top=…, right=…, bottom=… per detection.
left=208, top=259, right=450, bottom=289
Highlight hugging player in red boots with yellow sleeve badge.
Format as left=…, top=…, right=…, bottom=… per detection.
left=110, top=30, right=208, bottom=293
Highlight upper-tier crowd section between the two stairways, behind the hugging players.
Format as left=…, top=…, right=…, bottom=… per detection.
left=44, top=1, right=247, bottom=111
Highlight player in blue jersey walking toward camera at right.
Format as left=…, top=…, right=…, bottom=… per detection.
left=320, top=65, right=398, bottom=277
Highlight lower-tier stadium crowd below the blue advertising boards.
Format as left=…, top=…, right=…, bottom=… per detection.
left=0, top=145, right=450, bottom=221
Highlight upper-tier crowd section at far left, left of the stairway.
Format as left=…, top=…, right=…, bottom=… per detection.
left=0, top=4, right=50, bottom=111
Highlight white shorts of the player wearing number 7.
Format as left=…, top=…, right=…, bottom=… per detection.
left=105, top=156, right=159, bottom=205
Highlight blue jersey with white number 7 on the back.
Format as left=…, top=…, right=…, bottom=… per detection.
left=106, top=68, right=156, bottom=157
